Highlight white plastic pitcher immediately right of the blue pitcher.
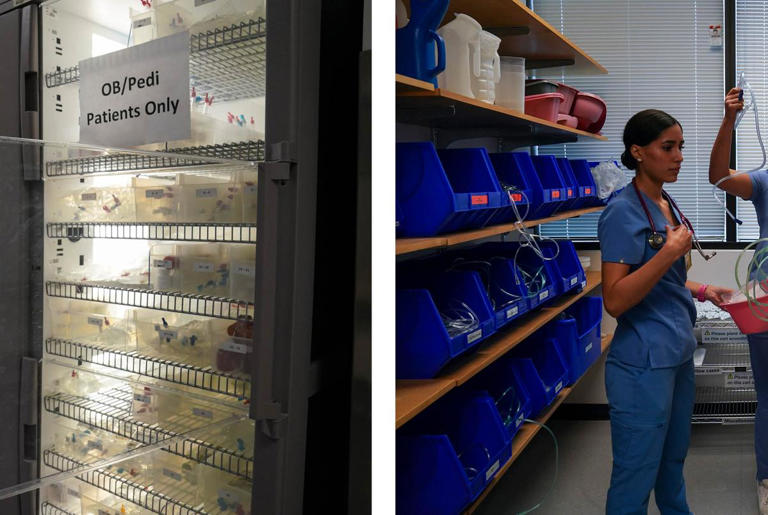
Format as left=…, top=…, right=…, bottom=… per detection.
left=437, top=14, right=483, bottom=98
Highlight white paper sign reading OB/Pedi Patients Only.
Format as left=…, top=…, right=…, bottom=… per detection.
left=79, top=32, right=190, bottom=147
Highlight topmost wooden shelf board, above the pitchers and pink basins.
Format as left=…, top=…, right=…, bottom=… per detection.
left=441, top=0, right=608, bottom=75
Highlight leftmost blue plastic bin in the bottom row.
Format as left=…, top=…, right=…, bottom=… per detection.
left=396, top=392, right=512, bottom=515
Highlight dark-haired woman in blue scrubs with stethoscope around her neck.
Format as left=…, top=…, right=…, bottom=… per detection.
left=598, top=109, right=730, bottom=515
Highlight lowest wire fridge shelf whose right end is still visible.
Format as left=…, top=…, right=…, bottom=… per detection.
left=44, top=393, right=253, bottom=479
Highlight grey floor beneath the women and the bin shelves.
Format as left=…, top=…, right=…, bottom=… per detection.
left=477, top=420, right=758, bottom=515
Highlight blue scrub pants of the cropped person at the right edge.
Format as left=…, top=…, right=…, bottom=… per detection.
left=747, top=333, right=768, bottom=481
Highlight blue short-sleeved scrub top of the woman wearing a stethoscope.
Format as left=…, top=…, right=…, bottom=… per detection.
left=598, top=184, right=696, bottom=368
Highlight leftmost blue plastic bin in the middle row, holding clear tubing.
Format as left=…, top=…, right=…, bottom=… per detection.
left=395, top=268, right=496, bottom=379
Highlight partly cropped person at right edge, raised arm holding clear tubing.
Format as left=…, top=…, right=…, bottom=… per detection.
left=709, top=88, right=768, bottom=515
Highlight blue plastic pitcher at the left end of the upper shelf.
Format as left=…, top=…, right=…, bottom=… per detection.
left=395, top=0, right=449, bottom=86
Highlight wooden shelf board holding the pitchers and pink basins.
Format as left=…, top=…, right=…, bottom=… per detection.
left=397, top=88, right=607, bottom=143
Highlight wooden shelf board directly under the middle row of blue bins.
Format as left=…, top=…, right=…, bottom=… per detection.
left=395, top=272, right=601, bottom=428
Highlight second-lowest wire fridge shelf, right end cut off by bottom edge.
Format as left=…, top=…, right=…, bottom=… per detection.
left=43, top=450, right=207, bottom=515
